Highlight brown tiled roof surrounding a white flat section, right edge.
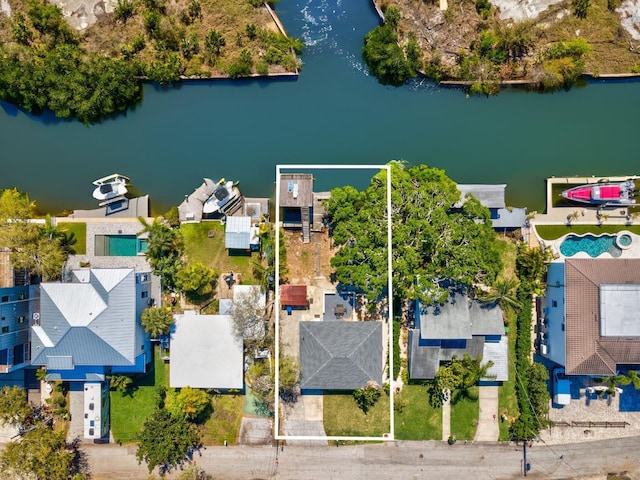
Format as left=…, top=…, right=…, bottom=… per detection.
left=565, top=259, right=640, bottom=375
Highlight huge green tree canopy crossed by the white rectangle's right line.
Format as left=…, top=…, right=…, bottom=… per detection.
left=327, top=162, right=501, bottom=302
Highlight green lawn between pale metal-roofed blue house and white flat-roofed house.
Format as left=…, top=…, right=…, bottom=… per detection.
left=111, top=346, right=169, bottom=443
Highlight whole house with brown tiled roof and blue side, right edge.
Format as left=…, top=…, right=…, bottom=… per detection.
left=540, top=258, right=640, bottom=376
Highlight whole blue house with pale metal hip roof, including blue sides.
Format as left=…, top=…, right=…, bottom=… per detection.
left=31, top=268, right=153, bottom=381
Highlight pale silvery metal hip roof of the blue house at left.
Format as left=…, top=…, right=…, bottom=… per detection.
left=31, top=269, right=139, bottom=370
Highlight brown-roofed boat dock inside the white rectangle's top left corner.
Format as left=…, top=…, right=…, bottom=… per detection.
left=277, top=173, right=313, bottom=243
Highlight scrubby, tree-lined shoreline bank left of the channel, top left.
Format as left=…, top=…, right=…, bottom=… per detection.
left=0, top=0, right=303, bottom=124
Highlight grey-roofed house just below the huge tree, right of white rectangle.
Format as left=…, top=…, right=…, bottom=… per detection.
left=409, top=292, right=509, bottom=381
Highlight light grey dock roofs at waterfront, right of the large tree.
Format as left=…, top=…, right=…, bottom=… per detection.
left=454, top=184, right=527, bottom=230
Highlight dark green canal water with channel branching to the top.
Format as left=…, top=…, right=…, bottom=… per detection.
left=0, top=0, right=640, bottom=212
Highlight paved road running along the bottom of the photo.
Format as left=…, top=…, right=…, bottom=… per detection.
left=84, top=437, right=640, bottom=480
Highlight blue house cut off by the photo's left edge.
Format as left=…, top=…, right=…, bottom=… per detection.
left=0, top=285, right=38, bottom=386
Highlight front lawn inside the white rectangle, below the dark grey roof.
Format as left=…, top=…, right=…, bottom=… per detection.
left=323, top=392, right=390, bottom=437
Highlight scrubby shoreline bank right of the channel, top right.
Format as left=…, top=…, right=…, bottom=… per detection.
left=363, top=0, right=640, bottom=95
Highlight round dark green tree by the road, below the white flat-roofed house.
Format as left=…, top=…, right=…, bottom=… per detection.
left=136, top=408, right=202, bottom=473
